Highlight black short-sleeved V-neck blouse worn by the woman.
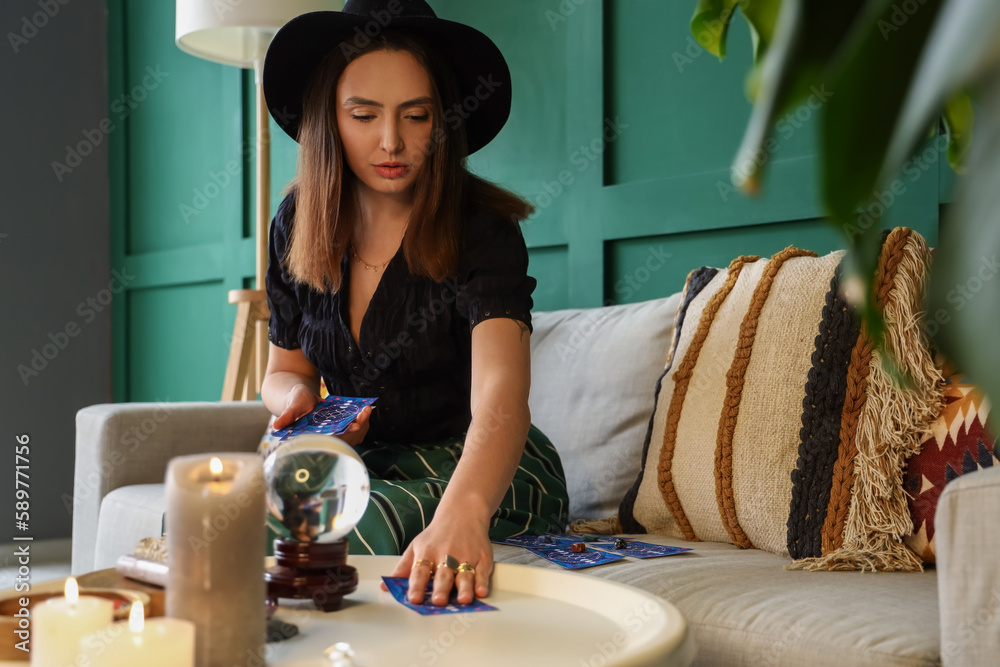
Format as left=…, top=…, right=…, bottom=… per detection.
left=265, top=194, right=536, bottom=442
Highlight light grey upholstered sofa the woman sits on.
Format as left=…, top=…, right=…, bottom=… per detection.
left=72, top=295, right=1000, bottom=667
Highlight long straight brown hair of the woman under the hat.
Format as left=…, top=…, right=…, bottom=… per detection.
left=283, top=30, right=534, bottom=292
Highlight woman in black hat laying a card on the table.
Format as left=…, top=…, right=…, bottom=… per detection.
left=262, top=0, right=568, bottom=605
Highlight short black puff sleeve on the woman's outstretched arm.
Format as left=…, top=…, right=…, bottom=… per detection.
left=455, top=212, right=537, bottom=332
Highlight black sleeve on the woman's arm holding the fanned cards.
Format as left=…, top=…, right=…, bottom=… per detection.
left=264, top=194, right=302, bottom=350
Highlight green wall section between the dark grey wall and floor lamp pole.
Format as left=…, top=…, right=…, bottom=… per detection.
left=108, top=0, right=254, bottom=401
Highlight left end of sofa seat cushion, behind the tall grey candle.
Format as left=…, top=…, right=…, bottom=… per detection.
left=94, top=484, right=167, bottom=570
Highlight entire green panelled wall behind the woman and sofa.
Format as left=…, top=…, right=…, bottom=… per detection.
left=109, top=0, right=954, bottom=401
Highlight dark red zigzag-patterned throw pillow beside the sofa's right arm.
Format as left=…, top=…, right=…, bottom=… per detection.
left=904, top=374, right=1000, bottom=563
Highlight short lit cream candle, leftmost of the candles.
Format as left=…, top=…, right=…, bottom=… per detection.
left=30, top=577, right=114, bottom=667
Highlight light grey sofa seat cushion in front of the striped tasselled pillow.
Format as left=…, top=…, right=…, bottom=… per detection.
left=493, top=535, right=941, bottom=667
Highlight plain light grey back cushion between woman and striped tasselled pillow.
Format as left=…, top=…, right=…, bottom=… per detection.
left=528, top=293, right=681, bottom=520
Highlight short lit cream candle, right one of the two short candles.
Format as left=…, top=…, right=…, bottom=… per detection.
left=80, top=602, right=195, bottom=667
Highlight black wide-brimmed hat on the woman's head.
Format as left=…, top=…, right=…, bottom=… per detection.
left=263, top=0, right=511, bottom=154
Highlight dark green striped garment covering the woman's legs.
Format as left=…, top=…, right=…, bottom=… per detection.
left=268, top=424, right=569, bottom=555
